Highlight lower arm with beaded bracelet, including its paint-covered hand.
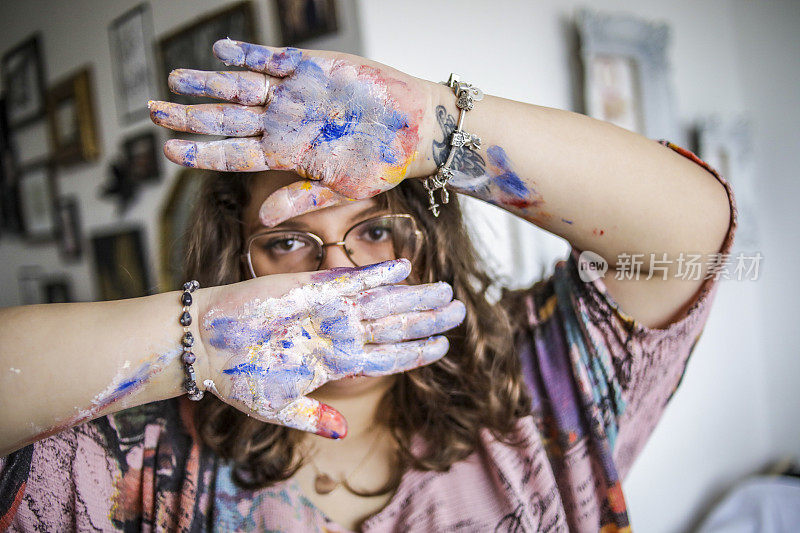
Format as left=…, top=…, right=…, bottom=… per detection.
left=0, top=260, right=464, bottom=456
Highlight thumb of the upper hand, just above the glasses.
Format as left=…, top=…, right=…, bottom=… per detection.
left=258, top=180, right=352, bottom=228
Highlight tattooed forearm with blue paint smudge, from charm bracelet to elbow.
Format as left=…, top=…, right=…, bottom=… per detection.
left=422, top=86, right=730, bottom=267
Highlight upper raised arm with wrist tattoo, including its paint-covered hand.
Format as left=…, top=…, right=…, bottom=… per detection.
left=151, top=40, right=732, bottom=326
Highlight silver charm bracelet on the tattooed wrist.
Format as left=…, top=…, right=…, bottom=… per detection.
left=425, top=74, right=483, bottom=217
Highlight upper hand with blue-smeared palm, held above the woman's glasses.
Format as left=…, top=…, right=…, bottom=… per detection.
left=150, top=39, right=437, bottom=226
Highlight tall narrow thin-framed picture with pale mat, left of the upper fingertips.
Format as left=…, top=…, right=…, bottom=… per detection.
left=108, top=2, right=156, bottom=124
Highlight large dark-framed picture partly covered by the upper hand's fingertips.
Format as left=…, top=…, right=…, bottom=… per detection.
left=158, top=1, right=255, bottom=104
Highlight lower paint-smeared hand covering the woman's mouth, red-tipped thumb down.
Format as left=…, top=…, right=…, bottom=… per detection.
left=199, top=259, right=465, bottom=438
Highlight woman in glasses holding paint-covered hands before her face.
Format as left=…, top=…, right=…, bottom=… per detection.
left=0, top=40, right=736, bottom=531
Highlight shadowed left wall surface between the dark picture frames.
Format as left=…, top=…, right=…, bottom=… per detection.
left=0, top=0, right=361, bottom=306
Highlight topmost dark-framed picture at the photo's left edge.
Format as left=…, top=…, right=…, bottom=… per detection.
left=0, top=34, right=46, bottom=128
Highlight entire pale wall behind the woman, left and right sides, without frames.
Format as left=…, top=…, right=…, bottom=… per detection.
left=0, top=0, right=800, bottom=531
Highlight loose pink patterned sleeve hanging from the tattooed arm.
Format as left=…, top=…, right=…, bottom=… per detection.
left=508, top=141, right=736, bottom=530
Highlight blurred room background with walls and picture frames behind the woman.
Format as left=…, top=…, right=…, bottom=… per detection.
left=0, top=0, right=800, bottom=531
